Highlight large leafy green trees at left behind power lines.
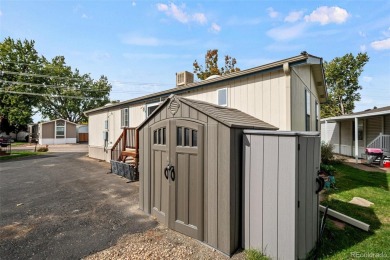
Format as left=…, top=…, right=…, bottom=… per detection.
left=0, top=38, right=112, bottom=126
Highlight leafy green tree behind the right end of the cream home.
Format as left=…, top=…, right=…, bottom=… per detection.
left=321, top=53, right=369, bottom=118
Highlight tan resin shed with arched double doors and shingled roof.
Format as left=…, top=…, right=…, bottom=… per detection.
left=138, top=95, right=277, bottom=255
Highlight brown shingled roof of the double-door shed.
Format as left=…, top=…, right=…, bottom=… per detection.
left=138, top=95, right=278, bottom=130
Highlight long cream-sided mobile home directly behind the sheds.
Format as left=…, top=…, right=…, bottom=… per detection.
left=85, top=52, right=327, bottom=161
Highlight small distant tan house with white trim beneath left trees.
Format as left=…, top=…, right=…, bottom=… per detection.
left=29, top=119, right=76, bottom=145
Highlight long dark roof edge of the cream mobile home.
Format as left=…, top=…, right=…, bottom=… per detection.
left=84, top=52, right=327, bottom=116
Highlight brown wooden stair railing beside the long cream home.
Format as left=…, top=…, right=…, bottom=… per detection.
left=111, top=128, right=139, bottom=167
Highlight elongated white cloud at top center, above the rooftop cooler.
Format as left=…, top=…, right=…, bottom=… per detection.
left=156, top=3, right=207, bottom=24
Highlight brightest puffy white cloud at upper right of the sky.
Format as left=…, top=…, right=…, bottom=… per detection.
left=305, top=6, right=350, bottom=25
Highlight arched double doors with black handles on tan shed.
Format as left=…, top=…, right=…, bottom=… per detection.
left=150, top=119, right=204, bottom=240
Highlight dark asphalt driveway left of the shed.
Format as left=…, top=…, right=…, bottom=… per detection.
left=0, top=149, right=157, bottom=259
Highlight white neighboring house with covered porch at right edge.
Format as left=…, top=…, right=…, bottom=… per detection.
left=321, top=106, right=390, bottom=158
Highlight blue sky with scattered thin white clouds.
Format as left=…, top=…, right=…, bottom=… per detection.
left=0, top=0, right=390, bottom=116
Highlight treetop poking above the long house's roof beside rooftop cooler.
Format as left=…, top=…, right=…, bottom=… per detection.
left=193, top=49, right=240, bottom=80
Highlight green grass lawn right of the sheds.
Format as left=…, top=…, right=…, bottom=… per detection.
left=319, top=164, right=390, bottom=259
